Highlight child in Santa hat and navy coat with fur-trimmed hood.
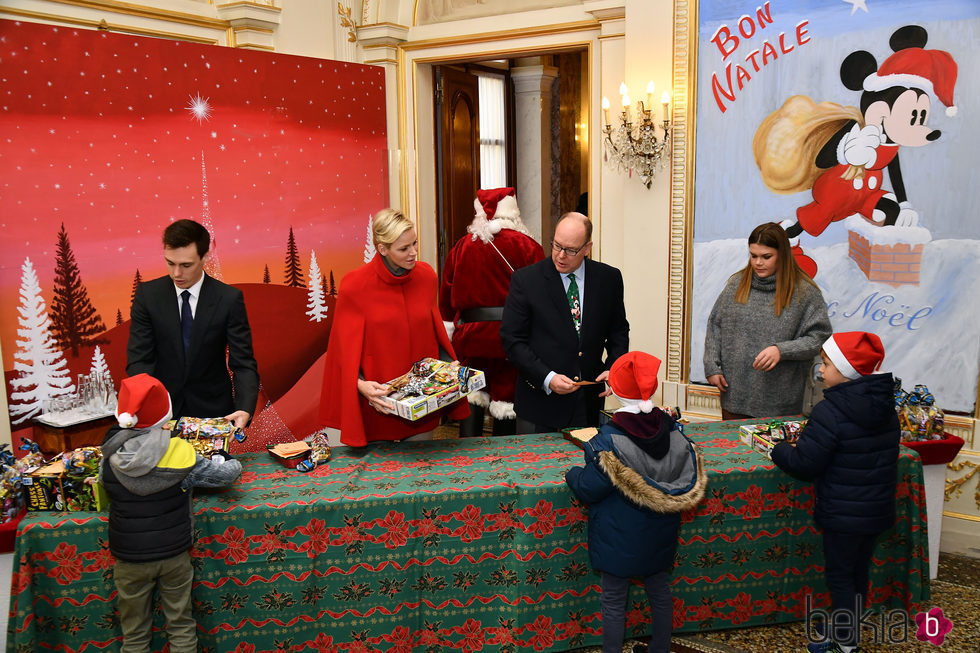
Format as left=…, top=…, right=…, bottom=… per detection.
left=565, top=351, right=707, bottom=653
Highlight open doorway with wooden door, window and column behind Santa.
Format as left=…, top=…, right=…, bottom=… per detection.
left=432, top=49, right=589, bottom=273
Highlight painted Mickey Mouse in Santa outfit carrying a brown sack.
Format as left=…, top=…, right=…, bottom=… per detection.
left=752, top=25, right=957, bottom=277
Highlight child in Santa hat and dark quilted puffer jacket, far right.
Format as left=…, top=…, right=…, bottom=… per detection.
left=772, top=331, right=901, bottom=653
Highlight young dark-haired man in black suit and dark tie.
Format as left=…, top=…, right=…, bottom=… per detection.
left=126, top=220, right=259, bottom=428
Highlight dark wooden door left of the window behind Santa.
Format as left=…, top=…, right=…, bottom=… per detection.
left=435, top=66, right=480, bottom=273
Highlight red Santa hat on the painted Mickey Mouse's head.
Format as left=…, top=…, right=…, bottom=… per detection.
left=864, top=48, right=957, bottom=117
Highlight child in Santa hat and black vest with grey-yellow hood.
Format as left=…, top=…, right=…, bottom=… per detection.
left=99, top=374, right=242, bottom=653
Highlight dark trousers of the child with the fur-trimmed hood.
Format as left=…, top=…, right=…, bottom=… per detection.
left=600, top=571, right=674, bottom=653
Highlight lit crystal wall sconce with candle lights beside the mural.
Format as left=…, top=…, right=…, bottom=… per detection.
left=602, top=82, right=670, bottom=188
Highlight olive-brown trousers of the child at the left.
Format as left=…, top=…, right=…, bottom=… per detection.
left=113, top=551, right=197, bottom=653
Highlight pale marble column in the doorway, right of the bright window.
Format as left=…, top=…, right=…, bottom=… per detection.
left=511, top=63, right=558, bottom=242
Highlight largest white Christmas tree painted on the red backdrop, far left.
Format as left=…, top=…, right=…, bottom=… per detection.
left=10, top=258, right=75, bottom=424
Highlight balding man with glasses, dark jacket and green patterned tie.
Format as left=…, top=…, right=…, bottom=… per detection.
left=500, top=213, right=629, bottom=433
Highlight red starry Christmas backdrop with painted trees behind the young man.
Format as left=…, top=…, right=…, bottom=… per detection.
left=0, top=21, right=387, bottom=449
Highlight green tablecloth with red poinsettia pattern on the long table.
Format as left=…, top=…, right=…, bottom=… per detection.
left=7, top=422, right=929, bottom=653
